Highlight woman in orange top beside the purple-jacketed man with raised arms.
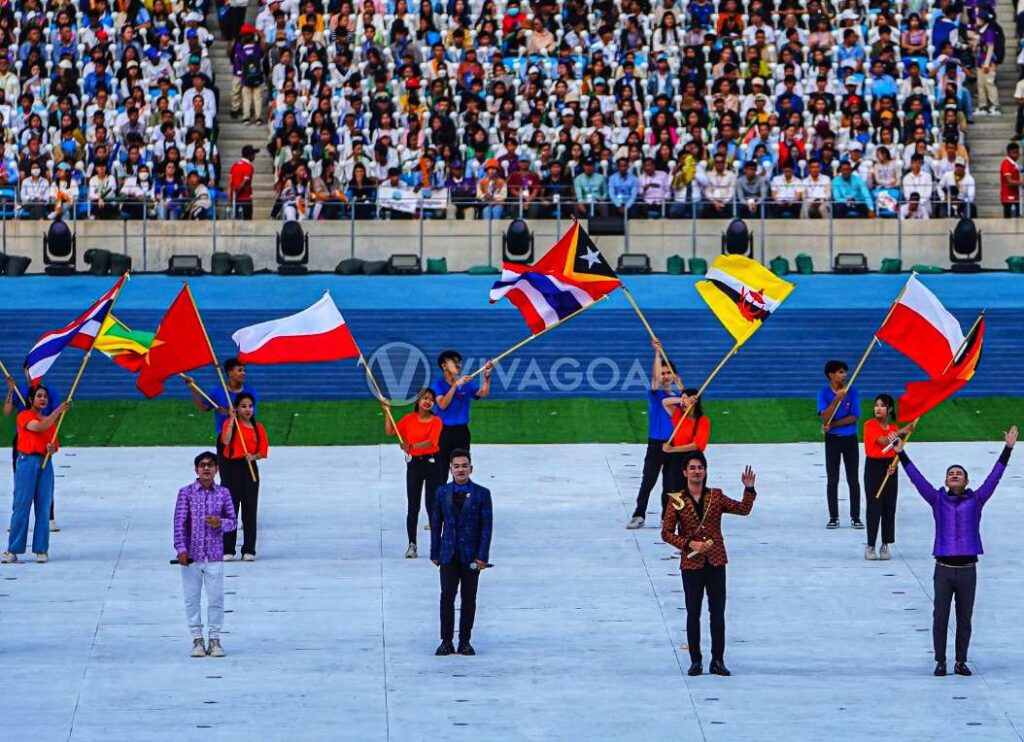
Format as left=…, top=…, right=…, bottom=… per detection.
left=864, top=394, right=913, bottom=560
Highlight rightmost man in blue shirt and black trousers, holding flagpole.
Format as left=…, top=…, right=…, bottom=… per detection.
left=818, top=360, right=864, bottom=529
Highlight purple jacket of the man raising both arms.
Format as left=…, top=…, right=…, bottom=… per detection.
left=900, top=448, right=1011, bottom=557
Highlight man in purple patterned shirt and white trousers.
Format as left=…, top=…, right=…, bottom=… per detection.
left=174, top=451, right=236, bottom=657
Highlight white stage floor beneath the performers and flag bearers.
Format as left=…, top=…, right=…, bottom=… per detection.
left=0, top=443, right=1024, bottom=742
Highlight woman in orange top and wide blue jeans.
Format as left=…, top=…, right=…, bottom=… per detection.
left=0, top=384, right=68, bottom=564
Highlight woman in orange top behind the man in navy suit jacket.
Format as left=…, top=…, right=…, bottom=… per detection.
left=381, top=389, right=441, bottom=559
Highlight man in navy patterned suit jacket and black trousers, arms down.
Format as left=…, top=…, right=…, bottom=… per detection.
left=430, top=448, right=494, bottom=657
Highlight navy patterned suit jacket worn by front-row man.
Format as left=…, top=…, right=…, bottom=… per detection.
left=430, top=481, right=494, bottom=564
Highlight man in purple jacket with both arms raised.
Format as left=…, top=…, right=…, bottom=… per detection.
left=894, top=426, right=1017, bottom=676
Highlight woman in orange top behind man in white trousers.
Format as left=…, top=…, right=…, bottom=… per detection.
left=220, top=392, right=270, bottom=562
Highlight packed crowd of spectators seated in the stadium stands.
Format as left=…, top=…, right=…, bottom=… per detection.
left=0, top=0, right=1024, bottom=219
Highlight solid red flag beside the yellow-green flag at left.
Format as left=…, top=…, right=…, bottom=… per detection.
left=135, top=286, right=217, bottom=397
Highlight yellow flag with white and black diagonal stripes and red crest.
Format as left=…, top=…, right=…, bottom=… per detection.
left=696, top=255, right=796, bottom=346
